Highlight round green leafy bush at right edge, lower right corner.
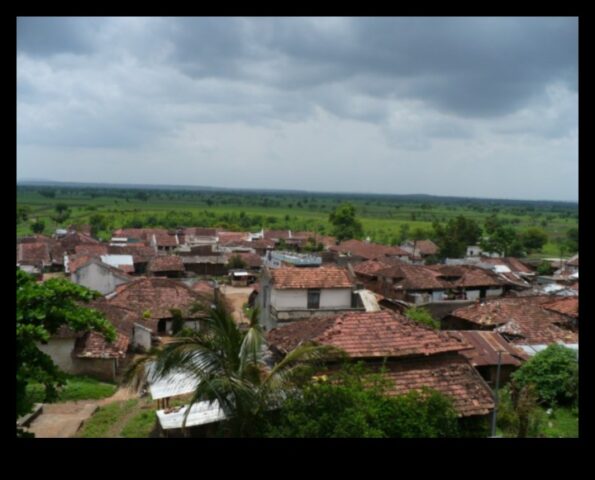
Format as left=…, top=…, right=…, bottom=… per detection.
left=512, top=344, right=578, bottom=405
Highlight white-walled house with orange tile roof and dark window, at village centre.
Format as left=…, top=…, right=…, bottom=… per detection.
left=259, top=265, right=365, bottom=330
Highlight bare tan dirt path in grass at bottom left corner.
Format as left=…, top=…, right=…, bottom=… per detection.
left=27, top=387, right=139, bottom=438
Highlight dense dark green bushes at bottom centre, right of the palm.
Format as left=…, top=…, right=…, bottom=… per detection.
left=265, top=365, right=458, bottom=438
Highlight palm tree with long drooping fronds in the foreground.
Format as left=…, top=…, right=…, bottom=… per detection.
left=126, top=294, right=341, bottom=437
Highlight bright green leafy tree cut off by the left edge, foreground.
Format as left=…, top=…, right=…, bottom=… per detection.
left=16, top=269, right=115, bottom=434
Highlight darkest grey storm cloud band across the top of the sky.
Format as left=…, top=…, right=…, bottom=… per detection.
left=17, top=18, right=578, bottom=117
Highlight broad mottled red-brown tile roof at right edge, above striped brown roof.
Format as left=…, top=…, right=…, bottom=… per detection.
left=450, top=296, right=578, bottom=345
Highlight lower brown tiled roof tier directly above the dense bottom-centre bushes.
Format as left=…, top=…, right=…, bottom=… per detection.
left=384, top=355, right=494, bottom=417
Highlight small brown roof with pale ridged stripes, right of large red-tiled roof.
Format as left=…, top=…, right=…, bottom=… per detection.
left=451, top=330, right=529, bottom=367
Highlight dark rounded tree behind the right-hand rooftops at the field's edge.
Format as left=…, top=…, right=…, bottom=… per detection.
left=433, top=215, right=481, bottom=258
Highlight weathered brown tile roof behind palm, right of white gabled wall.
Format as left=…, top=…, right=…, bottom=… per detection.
left=108, top=277, right=206, bottom=326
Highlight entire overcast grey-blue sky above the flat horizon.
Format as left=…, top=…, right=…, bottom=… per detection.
left=17, top=18, right=578, bottom=201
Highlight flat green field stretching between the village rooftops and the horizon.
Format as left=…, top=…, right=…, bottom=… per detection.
left=17, top=186, right=578, bottom=256
